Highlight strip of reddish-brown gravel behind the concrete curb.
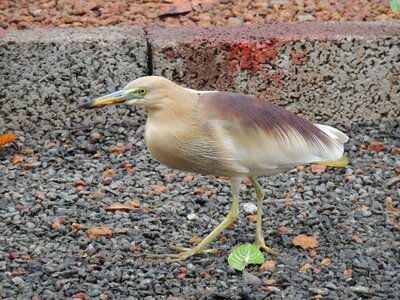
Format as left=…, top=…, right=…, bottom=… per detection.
left=0, top=0, right=400, bottom=29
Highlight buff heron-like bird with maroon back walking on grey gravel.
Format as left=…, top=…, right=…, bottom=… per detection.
left=79, top=76, right=349, bottom=261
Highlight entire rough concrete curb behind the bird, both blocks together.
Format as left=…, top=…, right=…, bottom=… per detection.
left=0, top=22, right=400, bottom=130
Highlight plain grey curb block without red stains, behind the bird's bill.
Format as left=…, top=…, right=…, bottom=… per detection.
left=0, top=27, right=148, bottom=132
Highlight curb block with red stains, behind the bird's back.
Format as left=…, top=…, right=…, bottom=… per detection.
left=148, top=22, right=400, bottom=123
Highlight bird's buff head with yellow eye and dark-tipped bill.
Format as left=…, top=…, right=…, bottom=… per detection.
left=80, top=76, right=176, bottom=109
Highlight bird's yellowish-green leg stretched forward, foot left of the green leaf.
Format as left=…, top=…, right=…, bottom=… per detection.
left=146, top=178, right=241, bottom=262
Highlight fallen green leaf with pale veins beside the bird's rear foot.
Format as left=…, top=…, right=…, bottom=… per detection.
left=228, top=244, right=265, bottom=271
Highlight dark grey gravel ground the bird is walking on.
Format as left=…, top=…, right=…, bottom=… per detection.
left=0, top=103, right=400, bottom=300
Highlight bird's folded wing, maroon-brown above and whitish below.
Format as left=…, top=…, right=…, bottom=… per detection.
left=199, top=92, right=348, bottom=173
